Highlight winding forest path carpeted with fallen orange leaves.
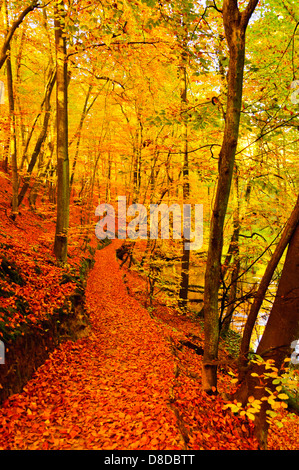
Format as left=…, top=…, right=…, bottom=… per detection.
left=0, top=240, right=184, bottom=450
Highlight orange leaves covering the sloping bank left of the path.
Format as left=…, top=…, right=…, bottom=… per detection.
left=0, top=174, right=95, bottom=341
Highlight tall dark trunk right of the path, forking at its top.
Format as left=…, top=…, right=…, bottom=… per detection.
left=202, top=0, right=258, bottom=393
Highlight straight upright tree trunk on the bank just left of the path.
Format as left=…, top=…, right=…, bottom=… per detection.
left=54, top=1, right=70, bottom=263
